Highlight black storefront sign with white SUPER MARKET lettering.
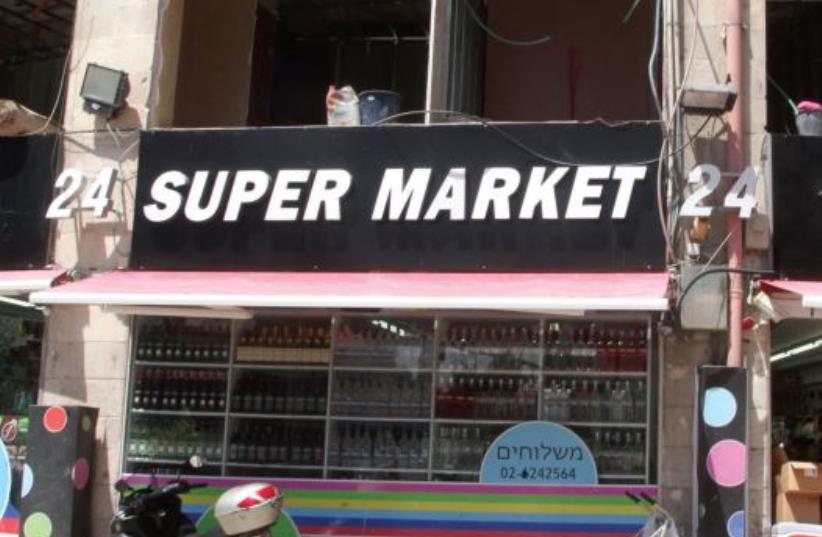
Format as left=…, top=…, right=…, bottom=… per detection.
left=130, top=123, right=664, bottom=271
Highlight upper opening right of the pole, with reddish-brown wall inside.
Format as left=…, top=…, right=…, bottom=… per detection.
left=448, top=0, right=659, bottom=121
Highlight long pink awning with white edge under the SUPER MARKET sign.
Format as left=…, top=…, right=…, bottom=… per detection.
left=31, top=271, right=668, bottom=312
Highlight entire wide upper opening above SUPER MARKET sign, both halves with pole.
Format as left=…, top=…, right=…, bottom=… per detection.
left=161, top=0, right=661, bottom=127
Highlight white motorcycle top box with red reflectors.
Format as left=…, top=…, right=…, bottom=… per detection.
left=214, top=483, right=283, bottom=535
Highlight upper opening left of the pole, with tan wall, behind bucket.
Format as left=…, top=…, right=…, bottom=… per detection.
left=171, top=0, right=431, bottom=127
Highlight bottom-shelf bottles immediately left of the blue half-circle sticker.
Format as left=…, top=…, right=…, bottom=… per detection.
left=434, top=425, right=501, bottom=471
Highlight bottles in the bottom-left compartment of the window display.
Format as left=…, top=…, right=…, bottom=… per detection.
left=128, top=420, right=223, bottom=462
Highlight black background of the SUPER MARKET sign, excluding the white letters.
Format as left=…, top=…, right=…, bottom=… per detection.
left=130, top=122, right=665, bottom=272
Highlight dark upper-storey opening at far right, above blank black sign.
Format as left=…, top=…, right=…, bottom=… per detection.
left=766, top=1, right=822, bottom=134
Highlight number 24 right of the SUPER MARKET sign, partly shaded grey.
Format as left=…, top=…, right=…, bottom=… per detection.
left=679, top=164, right=759, bottom=218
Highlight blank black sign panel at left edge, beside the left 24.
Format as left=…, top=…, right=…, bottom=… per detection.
left=0, top=134, right=57, bottom=270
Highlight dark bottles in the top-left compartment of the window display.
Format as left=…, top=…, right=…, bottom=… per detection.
left=136, top=318, right=231, bottom=362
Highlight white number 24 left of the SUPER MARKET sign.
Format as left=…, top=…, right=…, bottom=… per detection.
left=46, top=168, right=117, bottom=219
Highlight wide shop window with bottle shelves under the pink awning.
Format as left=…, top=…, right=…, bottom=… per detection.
left=125, top=313, right=655, bottom=484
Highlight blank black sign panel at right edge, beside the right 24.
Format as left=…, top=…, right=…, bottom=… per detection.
left=771, top=135, right=822, bottom=278
